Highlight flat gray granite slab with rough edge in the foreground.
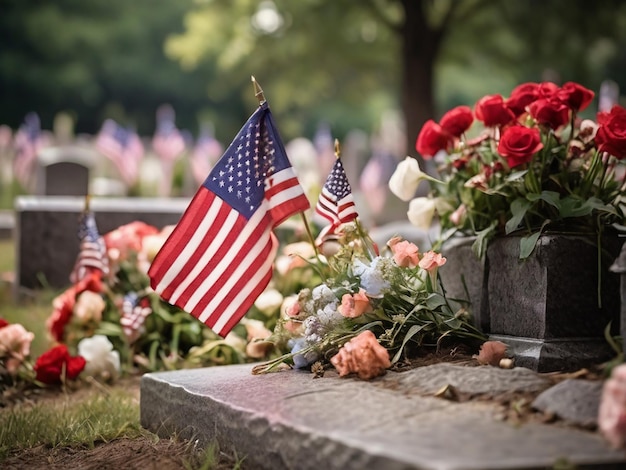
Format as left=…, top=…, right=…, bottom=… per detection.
left=140, top=365, right=626, bottom=470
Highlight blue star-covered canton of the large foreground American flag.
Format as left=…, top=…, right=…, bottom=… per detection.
left=203, top=103, right=290, bottom=219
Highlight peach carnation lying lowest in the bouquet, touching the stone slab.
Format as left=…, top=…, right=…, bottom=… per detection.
left=330, top=330, right=391, bottom=380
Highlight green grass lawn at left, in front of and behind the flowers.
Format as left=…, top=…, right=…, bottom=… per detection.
left=0, top=240, right=243, bottom=470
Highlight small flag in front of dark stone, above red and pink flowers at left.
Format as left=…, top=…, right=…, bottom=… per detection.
left=70, top=210, right=109, bottom=284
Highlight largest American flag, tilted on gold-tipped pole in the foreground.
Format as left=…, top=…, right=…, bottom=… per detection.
left=148, top=102, right=309, bottom=336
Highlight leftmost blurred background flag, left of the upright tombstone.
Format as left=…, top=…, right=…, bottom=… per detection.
left=13, top=113, right=46, bottom=188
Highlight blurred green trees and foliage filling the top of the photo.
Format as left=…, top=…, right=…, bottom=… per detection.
left=0, top=0, right=626, bottom=154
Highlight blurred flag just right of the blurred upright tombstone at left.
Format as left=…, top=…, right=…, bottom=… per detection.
left=96, top=119, right=144, bottom=186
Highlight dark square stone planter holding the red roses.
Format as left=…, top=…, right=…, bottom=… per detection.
left=442, top=233, right=624, bottom=372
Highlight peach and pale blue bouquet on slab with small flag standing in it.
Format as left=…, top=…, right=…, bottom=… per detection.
left=253, top=149, right=486, bottom=379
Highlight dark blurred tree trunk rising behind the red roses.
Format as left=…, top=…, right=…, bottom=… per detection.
left=400, top=0, right=441, bottom=172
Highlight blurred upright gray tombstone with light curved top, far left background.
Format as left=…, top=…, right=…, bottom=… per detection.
left=36, top=146, right=98, bottom=196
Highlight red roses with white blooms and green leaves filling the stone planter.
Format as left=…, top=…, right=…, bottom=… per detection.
left=389, top=82, right=626, bottom=258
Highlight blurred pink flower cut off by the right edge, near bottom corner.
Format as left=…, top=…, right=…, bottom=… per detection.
left=596, top=364, right=626, bottom=448
